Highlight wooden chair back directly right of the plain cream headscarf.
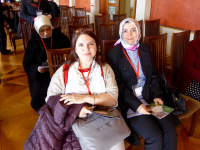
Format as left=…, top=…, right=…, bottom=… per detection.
left=51, top=17, right=68, bottom=36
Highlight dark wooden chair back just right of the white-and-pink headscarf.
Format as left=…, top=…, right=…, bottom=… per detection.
left=145, top=19, right=160, bottom=37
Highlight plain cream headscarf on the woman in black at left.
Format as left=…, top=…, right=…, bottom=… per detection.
left=34, top=15, right=53, bottom=38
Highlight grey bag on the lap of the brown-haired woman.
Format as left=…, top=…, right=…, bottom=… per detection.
left=72, top=107, right=131, bottom=150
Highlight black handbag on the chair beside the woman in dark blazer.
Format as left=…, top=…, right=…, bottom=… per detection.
left=157, top=70, right=188, bottom=115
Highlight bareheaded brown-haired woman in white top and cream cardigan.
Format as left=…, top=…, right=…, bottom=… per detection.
left=46, top=29, right=124, bottom=150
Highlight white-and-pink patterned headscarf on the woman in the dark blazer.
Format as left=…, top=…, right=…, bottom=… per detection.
left=115, top=18, right=141, bottom=50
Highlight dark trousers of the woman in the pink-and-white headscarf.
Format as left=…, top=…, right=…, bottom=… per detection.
left=128, top=115, right=177, bottom=150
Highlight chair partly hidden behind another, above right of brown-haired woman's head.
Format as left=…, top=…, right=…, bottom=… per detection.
left=94, top=15, right=110, bottom=38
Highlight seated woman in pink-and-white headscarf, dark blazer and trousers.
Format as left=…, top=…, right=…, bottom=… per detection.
left=108, top=18, right=177, bottom=150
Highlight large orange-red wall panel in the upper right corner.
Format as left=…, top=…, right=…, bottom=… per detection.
left=150, top=0, right=200, bottom=30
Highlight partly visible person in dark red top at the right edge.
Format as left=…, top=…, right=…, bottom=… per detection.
left=176, top=40, right=200, bottom=101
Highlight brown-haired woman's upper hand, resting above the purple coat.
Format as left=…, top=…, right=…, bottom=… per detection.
left=60, top=93, right=86, bottom=105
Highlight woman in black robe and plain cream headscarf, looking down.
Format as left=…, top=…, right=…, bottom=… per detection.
left=23, top=15, right=70, bottom=111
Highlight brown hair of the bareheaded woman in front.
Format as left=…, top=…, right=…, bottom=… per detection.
left=67, top=28, right=103, bottom=69
